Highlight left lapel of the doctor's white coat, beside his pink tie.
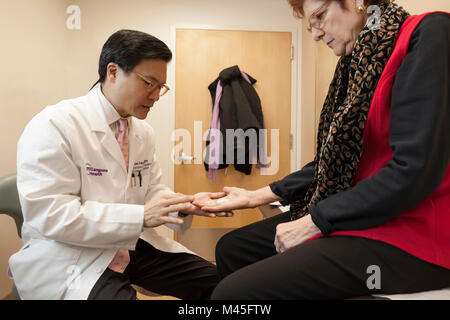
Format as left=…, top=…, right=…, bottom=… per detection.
left=87, top=88, right=127, bottom=174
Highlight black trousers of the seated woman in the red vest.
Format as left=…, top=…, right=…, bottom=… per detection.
left=212, top=212, right=450, bottom=300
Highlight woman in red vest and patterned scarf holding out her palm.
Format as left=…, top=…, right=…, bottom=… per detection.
left=195, top=0, right=450, bottom=299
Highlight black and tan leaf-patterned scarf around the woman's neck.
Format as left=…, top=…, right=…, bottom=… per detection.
left=291, top=3, right=409, bottom=220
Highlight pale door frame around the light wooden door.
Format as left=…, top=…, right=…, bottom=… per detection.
left=166, top=24, right=302, bottom=190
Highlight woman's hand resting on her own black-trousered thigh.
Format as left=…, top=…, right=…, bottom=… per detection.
left=274, top=215, right=321, bottom=253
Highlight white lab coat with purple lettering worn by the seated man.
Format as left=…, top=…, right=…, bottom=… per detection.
left=9, top=85, right=192, bottom=299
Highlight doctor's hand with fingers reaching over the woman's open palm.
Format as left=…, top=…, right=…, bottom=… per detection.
left=144, top=193, right=194, bottom=228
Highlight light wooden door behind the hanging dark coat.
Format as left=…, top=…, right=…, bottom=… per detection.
left=174, top=29, right=291, bottom=238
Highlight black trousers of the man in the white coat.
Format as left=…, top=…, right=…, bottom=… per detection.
left=88, top=239, right=219, bottom=300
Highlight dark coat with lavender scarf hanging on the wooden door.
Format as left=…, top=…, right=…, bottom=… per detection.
left=204, top=66, right=265, bottom=179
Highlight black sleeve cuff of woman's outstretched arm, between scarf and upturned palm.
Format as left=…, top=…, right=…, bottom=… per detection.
left=269, top=161, right=315, bottom=205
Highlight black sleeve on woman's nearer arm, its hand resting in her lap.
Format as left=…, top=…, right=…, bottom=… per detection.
left=309, top=14, right=450, bottom=234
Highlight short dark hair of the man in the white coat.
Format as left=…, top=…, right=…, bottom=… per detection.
left=92, top=30, right=172, bottom=87
